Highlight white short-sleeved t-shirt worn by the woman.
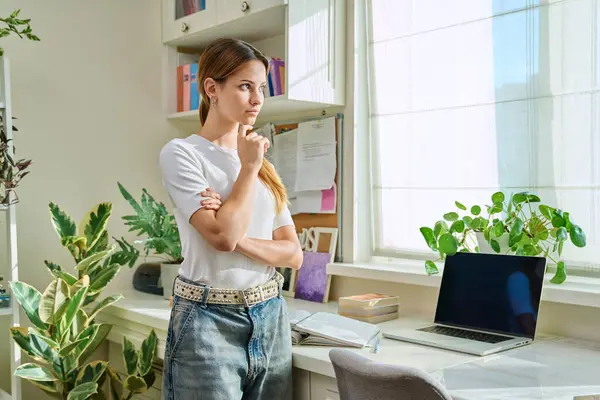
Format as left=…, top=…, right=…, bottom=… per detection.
left=160, top=134, right=294, bottom=289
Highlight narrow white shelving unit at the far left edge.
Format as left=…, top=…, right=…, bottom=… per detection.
left=0, top=57, right=21, bottom=400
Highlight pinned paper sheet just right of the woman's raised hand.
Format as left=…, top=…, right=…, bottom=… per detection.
left=273, top=129, right=298, bottom=198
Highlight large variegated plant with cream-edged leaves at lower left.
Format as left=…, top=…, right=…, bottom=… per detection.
left=10, top=203, right=158, bottom=400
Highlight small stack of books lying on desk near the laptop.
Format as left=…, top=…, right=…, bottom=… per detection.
left=338, top=293, right=400, bottom=324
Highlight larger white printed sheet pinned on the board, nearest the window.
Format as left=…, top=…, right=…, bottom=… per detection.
left=294, top=117, right=337, bottom=192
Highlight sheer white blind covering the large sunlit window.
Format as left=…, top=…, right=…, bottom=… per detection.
left=367, top=0, right=600, bottom=265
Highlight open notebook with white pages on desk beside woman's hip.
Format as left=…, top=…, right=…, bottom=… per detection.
left=290, top=310, right=379, bottom=348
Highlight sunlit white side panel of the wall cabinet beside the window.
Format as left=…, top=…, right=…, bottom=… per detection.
left=286, top=0, right=346, bottom=105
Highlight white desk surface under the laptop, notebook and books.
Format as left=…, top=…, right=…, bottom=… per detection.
left=99, top=290, right=600, bottom=400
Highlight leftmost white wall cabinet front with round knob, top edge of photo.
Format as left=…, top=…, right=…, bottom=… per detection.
left=162, top=0, right=217, bottom=42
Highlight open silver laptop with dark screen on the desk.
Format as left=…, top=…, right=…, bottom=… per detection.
left=382, top=253, right=546, bottom=356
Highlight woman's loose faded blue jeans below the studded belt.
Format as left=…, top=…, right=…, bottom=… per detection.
left=163, top=280, right=292, bottom=400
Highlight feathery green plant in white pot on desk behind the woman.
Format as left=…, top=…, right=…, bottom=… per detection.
left=117, top=182, right=183, bottom=299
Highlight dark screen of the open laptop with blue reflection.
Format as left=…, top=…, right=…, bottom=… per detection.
left=435, top=253, right=546, bottom=339
